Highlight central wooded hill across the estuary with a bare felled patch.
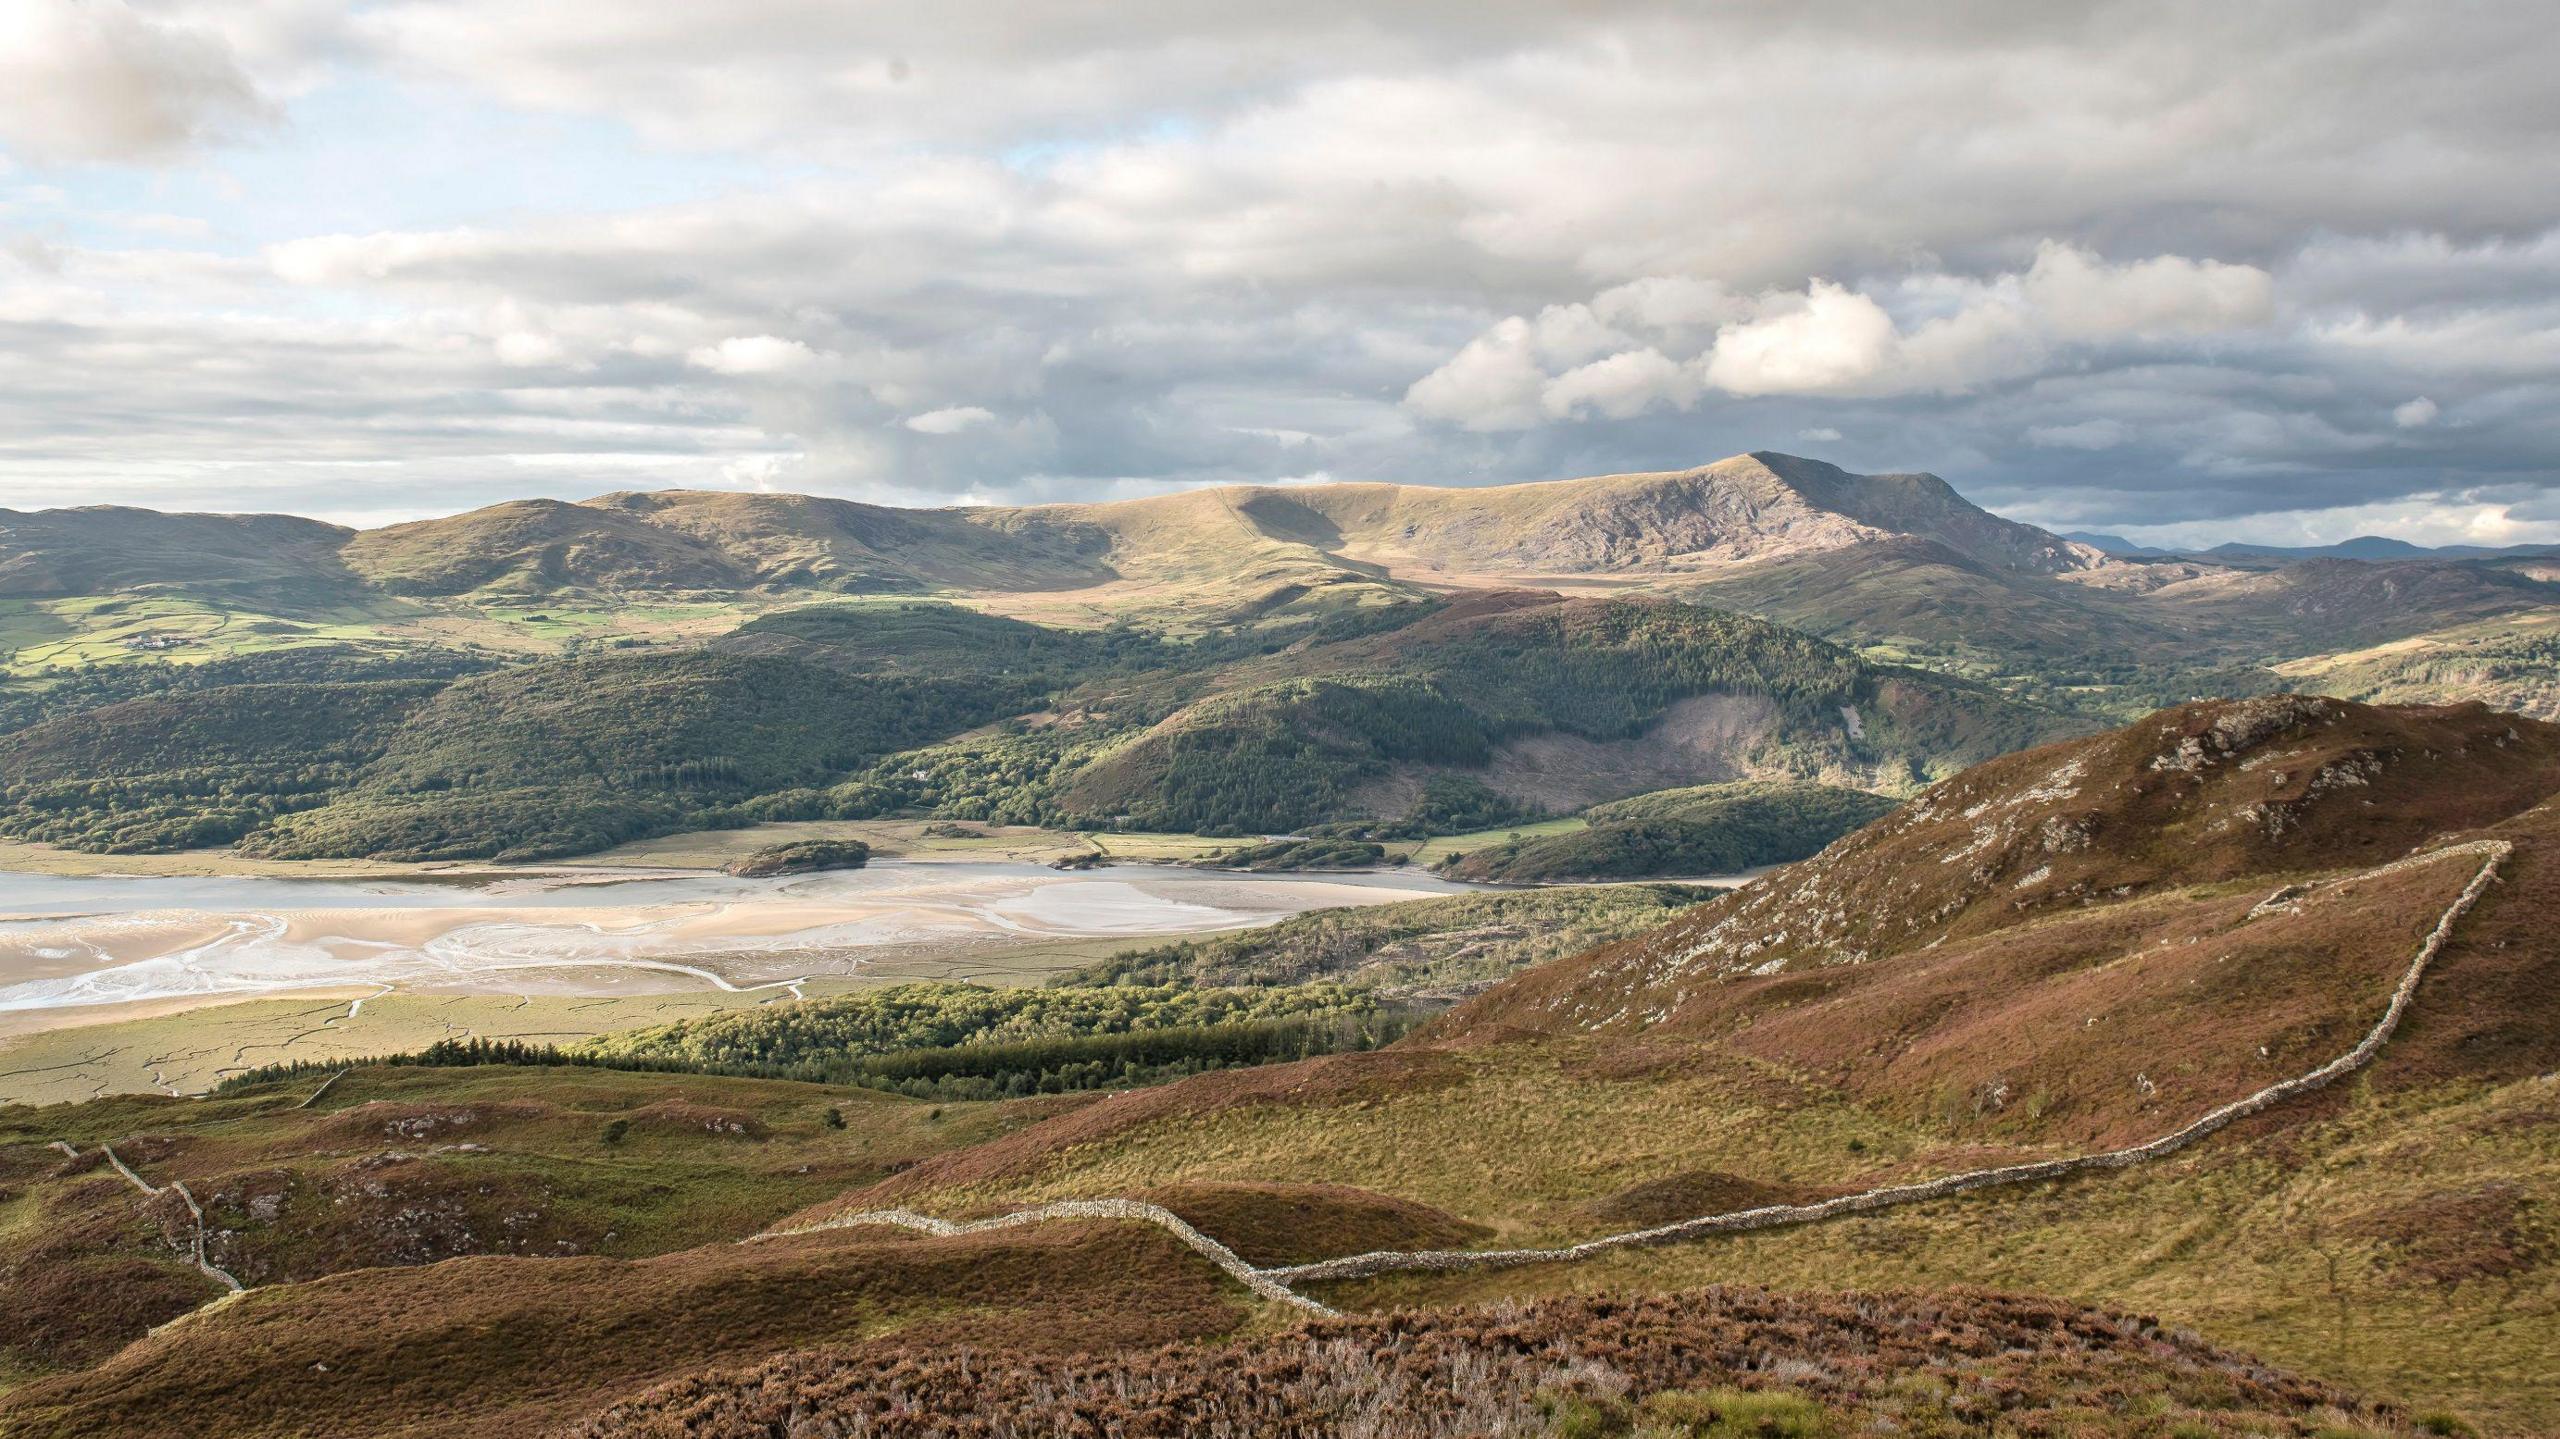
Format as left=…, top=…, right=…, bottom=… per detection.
left=1039, top=591, right=2063, bottom=832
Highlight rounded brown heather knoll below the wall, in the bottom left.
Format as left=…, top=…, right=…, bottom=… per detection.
left=0, top=1208, right=1257, bottom=1439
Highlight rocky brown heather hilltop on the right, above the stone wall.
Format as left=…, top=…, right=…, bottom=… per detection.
left=1454, top=696, right=2560, bottom=1013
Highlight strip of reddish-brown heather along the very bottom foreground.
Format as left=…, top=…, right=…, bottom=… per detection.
left=561, top=1288, right=2404, bottom=1439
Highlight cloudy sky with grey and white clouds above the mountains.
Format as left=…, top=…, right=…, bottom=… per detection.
left=0, top=0, right=2560, bottom=543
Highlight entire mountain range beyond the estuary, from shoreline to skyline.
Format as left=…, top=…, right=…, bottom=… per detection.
left=0, top=453, right=2560, bottom=860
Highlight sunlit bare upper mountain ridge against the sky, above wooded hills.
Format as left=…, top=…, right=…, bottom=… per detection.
left=0, top=451, right=2109, bottom=597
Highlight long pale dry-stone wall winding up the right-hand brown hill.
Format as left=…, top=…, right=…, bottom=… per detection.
left=740, top=840, right=2514, bottom=1314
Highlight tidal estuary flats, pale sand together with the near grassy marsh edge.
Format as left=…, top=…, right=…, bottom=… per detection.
left=0, top=863, right=1467, bottom=1101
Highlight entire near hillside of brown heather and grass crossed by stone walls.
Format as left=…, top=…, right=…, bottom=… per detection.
left=0, top=691, right=2560, bottom=1439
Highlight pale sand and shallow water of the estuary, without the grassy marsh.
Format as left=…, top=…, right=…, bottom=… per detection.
left=0, top=860, right=1472, bottom=1011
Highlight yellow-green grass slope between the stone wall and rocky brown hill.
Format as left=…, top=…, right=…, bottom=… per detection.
left=847, top=1042, right=1946, bottom=1244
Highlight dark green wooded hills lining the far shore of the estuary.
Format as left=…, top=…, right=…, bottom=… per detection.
left=0, top=591, right=2071, bottom=860
